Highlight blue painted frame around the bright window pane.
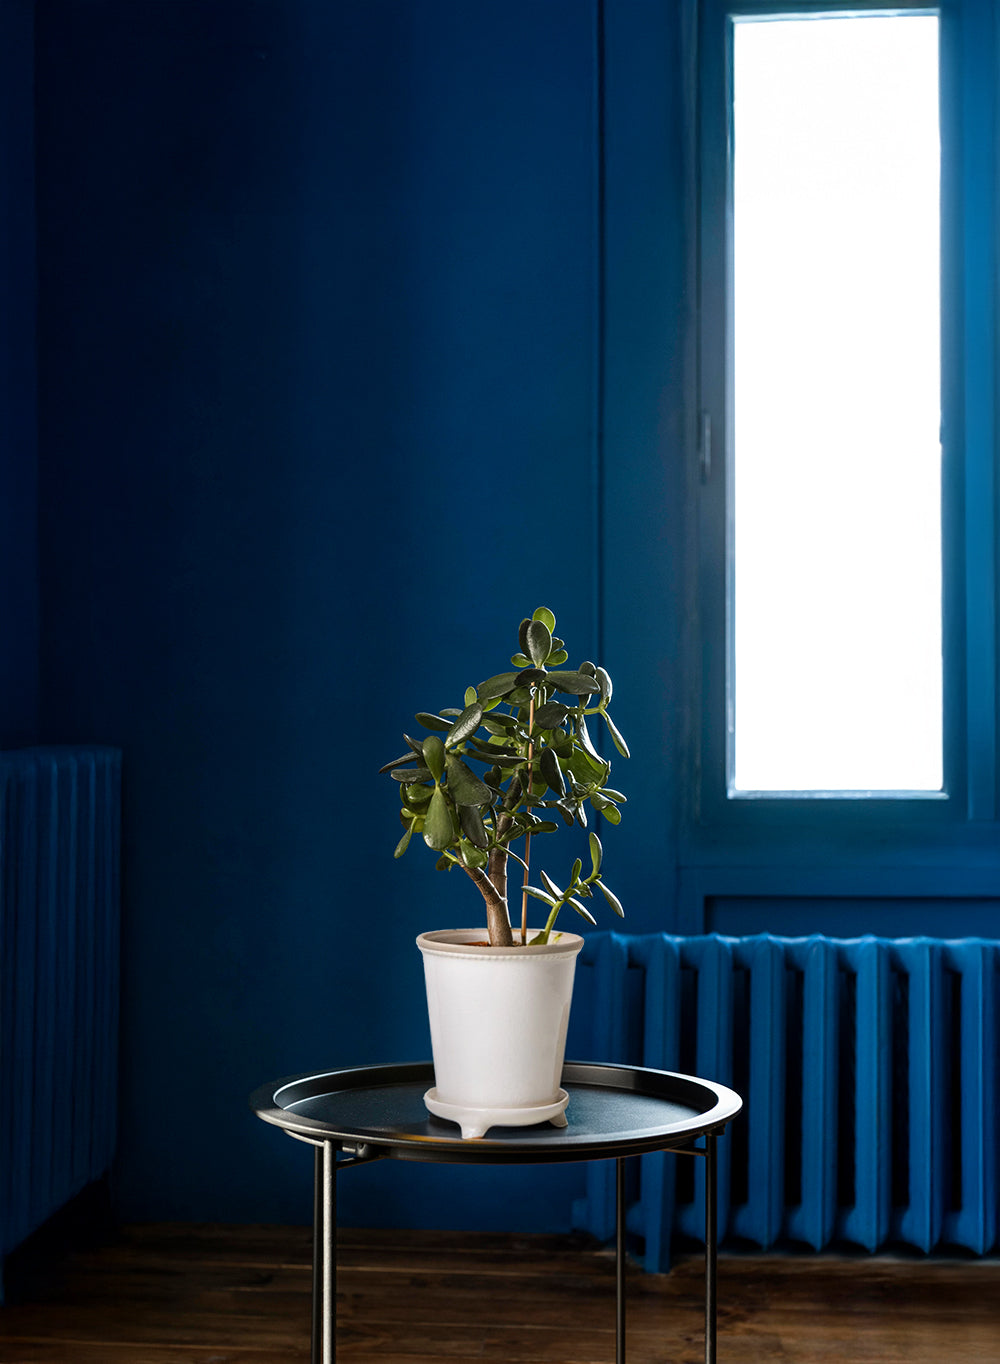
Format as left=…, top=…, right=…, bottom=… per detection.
left=682, top=0, right=997, bottom=865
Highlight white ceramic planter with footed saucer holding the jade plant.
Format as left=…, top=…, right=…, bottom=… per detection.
left=416, top=929, right=584, bottom=1138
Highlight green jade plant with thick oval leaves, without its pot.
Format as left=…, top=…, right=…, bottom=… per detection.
left=382, top=607, right=629, bottom=947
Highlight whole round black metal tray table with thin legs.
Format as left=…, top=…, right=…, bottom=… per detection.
left=250, top=1061, right=742, bottom=1364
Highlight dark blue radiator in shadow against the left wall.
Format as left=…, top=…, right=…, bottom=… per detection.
left=0, top=747, right=120, bottom=1300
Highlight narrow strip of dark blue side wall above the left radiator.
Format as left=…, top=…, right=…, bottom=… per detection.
left=0, top=0, right=38, bottom=747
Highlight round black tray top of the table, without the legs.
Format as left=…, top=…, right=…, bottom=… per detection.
left=250, top=1061, right=742, bottom=1165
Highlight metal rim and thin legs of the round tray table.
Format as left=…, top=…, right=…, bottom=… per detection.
left=250, top=1063, right=742, bottom=1364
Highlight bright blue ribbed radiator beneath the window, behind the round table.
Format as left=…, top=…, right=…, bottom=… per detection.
left=570, top=933, right=1000, bottom=1270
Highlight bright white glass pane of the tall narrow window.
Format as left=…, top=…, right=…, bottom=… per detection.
left=729, top=14, right=943, bottom=795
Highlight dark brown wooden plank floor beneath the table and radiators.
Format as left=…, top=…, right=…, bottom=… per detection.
left=0, top=1226, right=1000, bottom=1364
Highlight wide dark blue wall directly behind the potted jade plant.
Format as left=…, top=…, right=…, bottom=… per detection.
left=37, top=0, right=679, bottom=1229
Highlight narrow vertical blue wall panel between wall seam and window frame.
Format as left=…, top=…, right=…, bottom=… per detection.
left=600, top=0, right=696, bottom=933
